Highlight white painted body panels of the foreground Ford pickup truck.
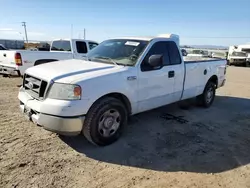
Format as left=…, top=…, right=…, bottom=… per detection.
left=18, top=34, right=226, bottom=132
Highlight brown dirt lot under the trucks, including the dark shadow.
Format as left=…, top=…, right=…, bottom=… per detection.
left=0, top=67, right=250, bottom=188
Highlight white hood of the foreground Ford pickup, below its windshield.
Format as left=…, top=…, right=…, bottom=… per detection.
left=25, top=59, right=124, bottom=83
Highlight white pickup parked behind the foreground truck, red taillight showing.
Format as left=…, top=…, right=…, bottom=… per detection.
left=0, top=39, right=98, bottom=76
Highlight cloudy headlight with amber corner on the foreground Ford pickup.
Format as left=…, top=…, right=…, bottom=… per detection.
left=48, top=83, right=82, bottom=100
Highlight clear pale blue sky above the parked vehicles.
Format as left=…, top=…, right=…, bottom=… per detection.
left=0, top=0, right=250, bottom=46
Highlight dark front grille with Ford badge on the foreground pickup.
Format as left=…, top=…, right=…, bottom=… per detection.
left=23, top=74, right=48, bottom=99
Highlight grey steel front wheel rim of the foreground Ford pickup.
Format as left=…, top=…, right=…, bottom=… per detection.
left=98, top=109, right=121, bottom=137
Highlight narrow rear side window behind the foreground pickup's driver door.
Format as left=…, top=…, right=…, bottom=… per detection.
left=167, top=41, right=181, bottom=65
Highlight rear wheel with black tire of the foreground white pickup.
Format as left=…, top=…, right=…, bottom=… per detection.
left=196, top=81, right=216, bottom=108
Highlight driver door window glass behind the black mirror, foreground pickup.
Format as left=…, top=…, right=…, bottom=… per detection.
left=141, top=41, right=170, bottom=71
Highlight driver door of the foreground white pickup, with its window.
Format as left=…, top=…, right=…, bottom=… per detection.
left=138, top=41, right=175, bottom=112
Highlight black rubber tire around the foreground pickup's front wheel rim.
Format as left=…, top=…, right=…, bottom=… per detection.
left=82, top=97, right=128, bottom=146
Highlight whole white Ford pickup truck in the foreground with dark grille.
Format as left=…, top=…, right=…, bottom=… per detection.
left=18, top=34, right=226, bottom=146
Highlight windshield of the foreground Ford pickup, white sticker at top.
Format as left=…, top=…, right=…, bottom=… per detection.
left=87, top=39, right=148, bottom=66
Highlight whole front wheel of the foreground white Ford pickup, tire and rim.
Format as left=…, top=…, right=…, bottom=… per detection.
left=83, top=97, right=127, bottom=146
